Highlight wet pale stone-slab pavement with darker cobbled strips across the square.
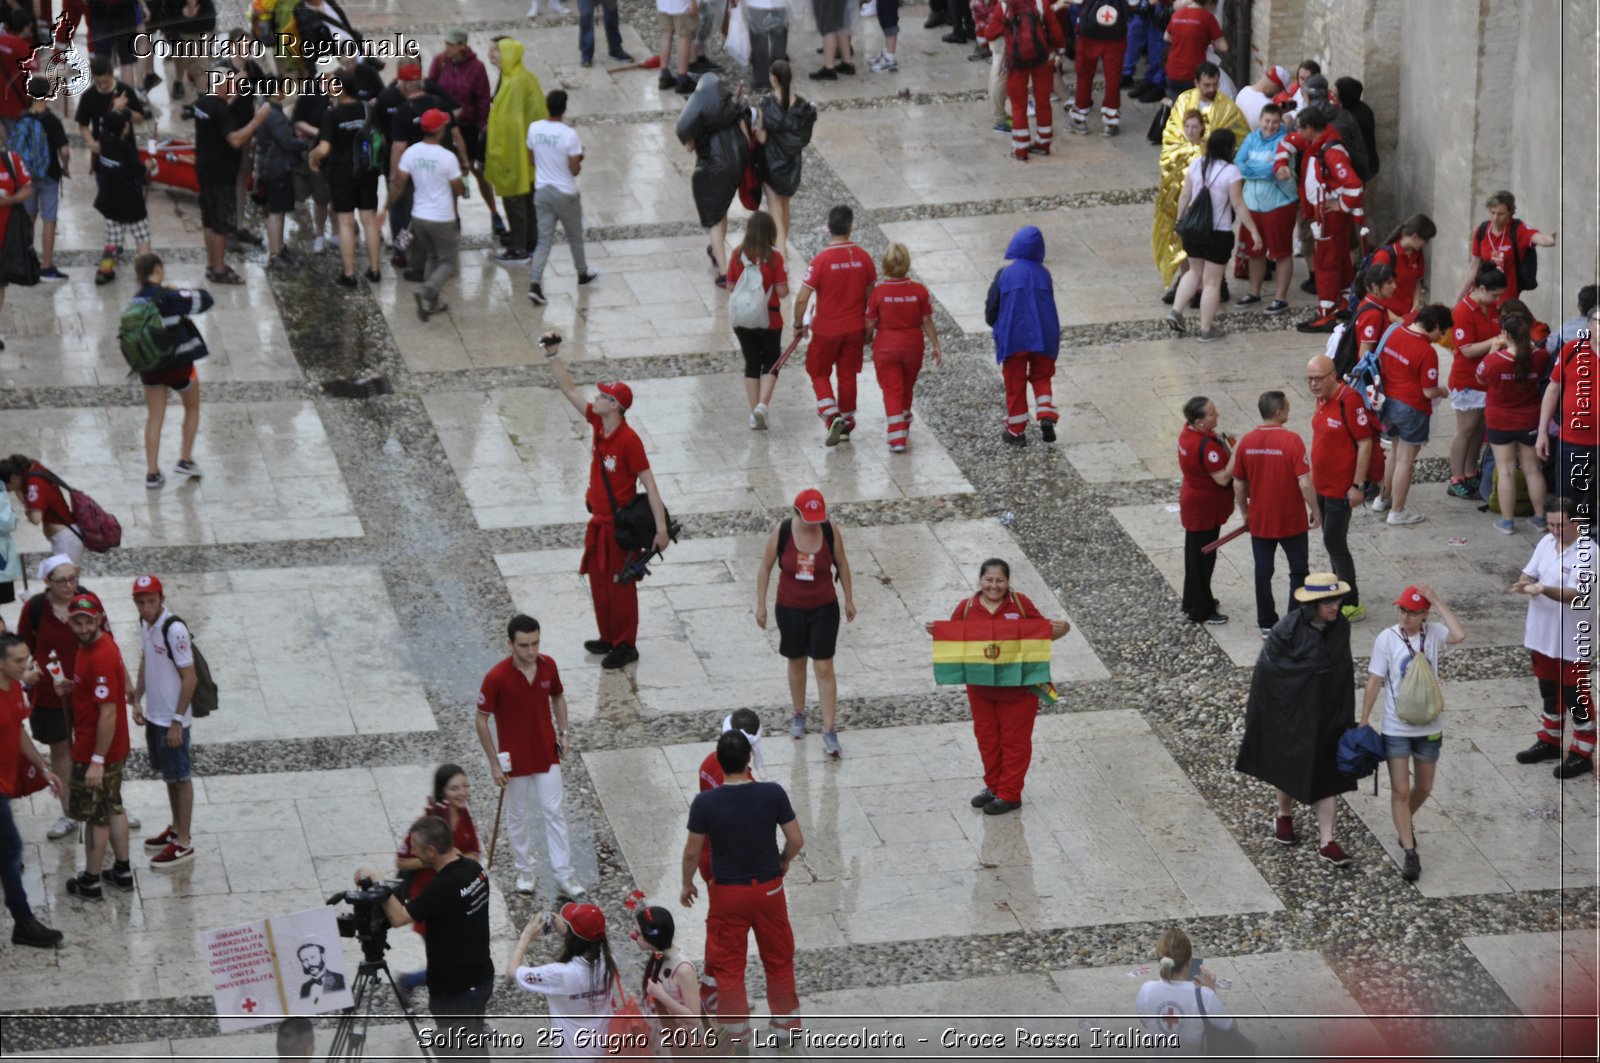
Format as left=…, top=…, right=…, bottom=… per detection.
left=0, top=0, right=1597, bottom=1058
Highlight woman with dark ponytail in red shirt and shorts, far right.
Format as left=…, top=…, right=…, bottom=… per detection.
left=1478, top=299, right=1550, bottom=535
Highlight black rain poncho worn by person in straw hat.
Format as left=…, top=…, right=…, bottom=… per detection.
left=1234, top=605, right=1355, bottom=804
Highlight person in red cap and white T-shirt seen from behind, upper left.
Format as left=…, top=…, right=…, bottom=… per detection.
left=378, top=107, right=466, bottom=322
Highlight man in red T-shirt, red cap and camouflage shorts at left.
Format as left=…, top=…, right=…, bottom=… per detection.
left=56, top=594, right=133, bottom=901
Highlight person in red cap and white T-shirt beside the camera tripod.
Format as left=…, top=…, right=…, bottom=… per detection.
left=506, top=901, right=618, bottom=1060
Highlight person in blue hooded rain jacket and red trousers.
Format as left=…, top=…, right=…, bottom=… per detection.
left=984, top=226, right=1061, bottom=447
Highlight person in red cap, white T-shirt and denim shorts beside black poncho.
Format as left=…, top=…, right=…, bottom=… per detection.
left=1362, top=583, right=1467, bottom=882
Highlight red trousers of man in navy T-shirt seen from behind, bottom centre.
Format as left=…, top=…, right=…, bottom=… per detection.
left=706, top=877, right=800, bottom=1028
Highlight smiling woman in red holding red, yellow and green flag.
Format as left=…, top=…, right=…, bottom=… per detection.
left=926, top=557, right=1072, bottom=816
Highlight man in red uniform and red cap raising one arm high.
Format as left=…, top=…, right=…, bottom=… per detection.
left=539, top=333, right=669, bottom=668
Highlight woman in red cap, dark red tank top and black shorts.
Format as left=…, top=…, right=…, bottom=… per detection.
left=755, top=487, right=856, bottom=757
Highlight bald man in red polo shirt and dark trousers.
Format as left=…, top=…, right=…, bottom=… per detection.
left=1306, top=354, right=1384, bottom=624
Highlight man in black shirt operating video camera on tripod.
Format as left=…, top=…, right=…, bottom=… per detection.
left=355, top=816, right=494, bottom=1057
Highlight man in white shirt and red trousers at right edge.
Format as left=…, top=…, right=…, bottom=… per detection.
left=1510, top=495, right=1600, bottom=778
